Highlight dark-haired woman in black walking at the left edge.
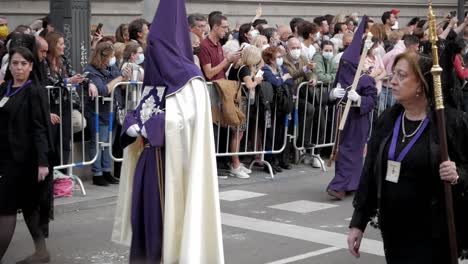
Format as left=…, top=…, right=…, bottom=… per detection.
left=0, top=47, right=50, bottom=263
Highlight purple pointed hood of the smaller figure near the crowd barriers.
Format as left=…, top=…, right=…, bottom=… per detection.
left=334, top=16, right=367, bottom=87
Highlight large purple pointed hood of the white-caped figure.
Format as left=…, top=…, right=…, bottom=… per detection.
left=143, top=0, right=203, bottom=95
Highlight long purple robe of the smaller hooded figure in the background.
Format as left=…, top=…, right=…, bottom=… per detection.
left=328, top=75, right=377, bottom=191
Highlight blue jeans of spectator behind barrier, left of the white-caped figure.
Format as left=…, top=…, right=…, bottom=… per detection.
left=88, top=124, right=112, bottom=176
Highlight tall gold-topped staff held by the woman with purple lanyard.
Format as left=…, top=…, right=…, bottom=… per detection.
left=429, top=0, right=458, bottom=264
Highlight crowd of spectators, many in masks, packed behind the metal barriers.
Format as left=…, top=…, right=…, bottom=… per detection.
left=0, top=7, right=468, bottom=182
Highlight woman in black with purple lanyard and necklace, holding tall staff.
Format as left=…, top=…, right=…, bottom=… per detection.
left=348, top=53, right=468, bottom=264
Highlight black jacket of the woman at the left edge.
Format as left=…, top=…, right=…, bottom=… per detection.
left=0, top=82, right=53, bottom=166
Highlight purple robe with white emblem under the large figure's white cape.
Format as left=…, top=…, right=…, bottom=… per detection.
left=122, top=88, right=165, bottom=264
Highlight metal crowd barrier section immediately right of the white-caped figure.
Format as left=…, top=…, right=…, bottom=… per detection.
left=207, top=82, right=290, bottom=178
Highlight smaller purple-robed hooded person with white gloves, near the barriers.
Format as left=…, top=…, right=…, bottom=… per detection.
left=327, top=16, right=377, bottom=200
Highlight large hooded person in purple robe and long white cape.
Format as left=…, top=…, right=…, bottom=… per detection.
left=113, top=0, right=224, bottom=264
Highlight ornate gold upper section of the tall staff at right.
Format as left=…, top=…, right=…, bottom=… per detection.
left=428, top=0, right=444, bottom=109
